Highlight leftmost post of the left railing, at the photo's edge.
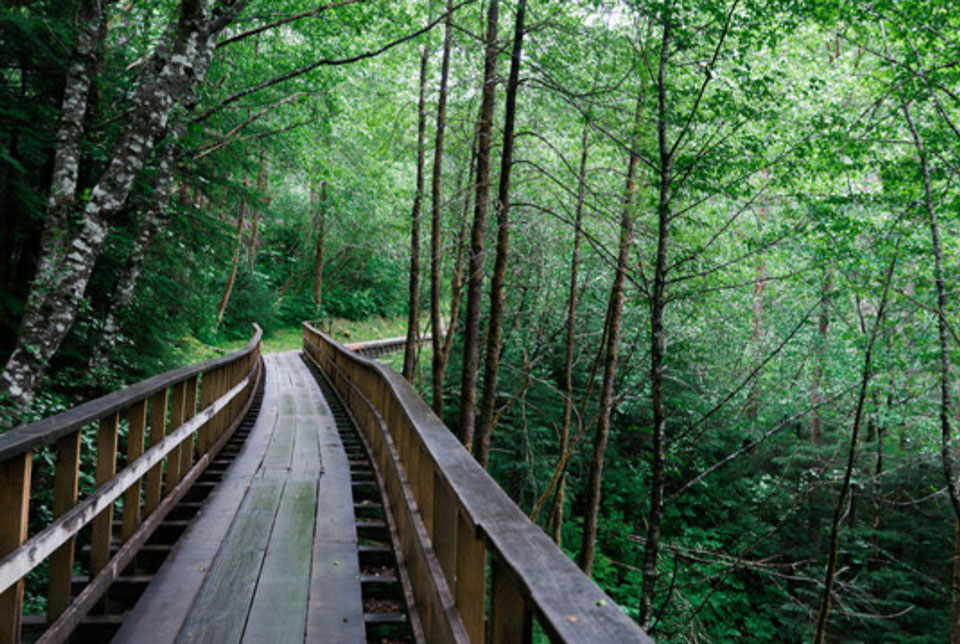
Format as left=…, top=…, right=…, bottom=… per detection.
left=0, top=452, right=33, bottom=644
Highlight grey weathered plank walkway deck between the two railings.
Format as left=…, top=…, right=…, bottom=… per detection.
left=113, top=351, right=364, bottom=644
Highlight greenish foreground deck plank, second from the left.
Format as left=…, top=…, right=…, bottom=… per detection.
left=176, top=478, right=283, bottom=644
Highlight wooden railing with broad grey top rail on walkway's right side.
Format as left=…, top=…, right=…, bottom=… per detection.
left=303, top=323, right=652, bottom=644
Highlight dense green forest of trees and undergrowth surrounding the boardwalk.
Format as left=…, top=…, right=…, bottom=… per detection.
left=0, top=0, right=960, bottom=643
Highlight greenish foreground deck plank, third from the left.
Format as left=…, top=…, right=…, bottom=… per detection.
left=242, top=479, right=316, bottom=644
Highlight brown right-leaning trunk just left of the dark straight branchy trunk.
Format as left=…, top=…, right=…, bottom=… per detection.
left=578, top=90, right=643, bottom=575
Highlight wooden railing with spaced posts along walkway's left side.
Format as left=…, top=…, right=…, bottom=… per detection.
left=0, top=325, right=262, bottom=644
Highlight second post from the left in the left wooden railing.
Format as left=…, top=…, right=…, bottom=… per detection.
left=47, top=431, right=80, bottom=624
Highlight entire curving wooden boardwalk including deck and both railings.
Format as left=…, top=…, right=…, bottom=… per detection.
left=0, top=323, right=652, bottom=644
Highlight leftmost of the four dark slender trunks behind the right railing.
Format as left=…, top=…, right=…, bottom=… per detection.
left=403, top=36, right=430, bottom=382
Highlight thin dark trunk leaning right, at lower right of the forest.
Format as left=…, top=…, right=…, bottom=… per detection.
left=813, top=247, right=897, bottom=644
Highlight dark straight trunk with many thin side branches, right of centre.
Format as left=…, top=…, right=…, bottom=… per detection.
left=640, top=17, right=673, bottom=629
